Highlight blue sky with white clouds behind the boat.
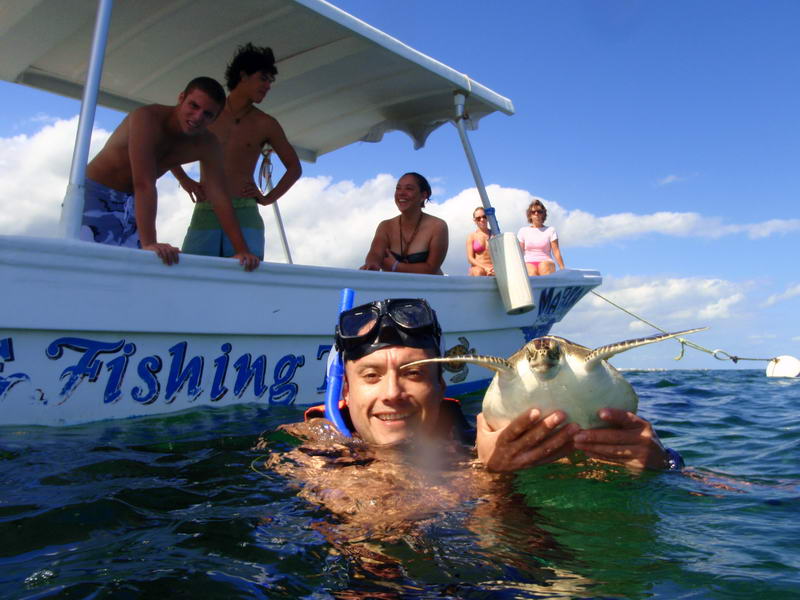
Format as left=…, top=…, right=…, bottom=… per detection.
left=0, top=0, right=800, bottom=368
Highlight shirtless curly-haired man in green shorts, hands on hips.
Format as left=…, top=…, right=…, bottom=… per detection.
left=172, top=44, right=302, bottom=259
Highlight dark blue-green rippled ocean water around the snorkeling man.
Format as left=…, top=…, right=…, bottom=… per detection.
left=0, top=370, right=800, bottom=599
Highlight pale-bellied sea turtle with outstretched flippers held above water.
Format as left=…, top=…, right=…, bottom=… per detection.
left=411, top=328, right=704, bottom=429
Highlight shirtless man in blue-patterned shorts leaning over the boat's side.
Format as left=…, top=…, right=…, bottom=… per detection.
left=81, top=77, right=259, bottom=271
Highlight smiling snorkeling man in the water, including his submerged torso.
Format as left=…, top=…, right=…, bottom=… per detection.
left=257, top=299, right=680, bottom=584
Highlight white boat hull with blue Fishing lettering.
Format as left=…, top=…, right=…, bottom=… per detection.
left=0, top=236, right=602, bottom=425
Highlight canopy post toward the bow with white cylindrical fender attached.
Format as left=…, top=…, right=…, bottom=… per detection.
left=453, top=91, right=534, bottom=315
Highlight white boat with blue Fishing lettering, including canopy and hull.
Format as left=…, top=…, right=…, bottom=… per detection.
left=0, top=0, right=602, bottom=425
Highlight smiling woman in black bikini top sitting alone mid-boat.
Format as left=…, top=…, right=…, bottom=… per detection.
left=360, top=173, right=449, bottom=275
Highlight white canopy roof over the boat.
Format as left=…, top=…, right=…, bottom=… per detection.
left=0, top=0, right=514, bottom=162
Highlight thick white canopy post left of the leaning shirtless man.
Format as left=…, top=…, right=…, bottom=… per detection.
left=60, top=0, right=114, bottom=239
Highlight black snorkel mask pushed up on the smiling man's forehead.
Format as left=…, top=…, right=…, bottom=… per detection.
left=336, top=298, right=442, bottom=361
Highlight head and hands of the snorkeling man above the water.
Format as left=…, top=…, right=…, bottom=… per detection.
left=306, top=299, right=682, bottom=472
